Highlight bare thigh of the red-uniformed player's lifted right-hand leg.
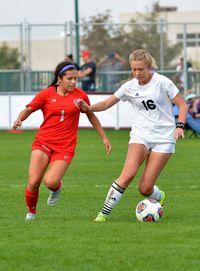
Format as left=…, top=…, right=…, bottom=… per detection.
left=44, top=160, right=69, bottom=186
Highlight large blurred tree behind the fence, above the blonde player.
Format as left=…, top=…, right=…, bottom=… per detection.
left=81, top=3, right=182, bottom=69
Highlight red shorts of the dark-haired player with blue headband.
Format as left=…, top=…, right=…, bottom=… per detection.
left=32, top=140, right=74, bottom=165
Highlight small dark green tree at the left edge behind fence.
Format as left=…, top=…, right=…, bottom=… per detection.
left=0, top=42, right=20, bottom=70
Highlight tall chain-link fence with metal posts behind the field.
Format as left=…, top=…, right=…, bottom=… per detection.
left=0, top=20, right=200, bottom=94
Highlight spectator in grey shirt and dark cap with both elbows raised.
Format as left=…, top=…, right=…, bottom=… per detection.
left=97, top=53, right=126, bottom=91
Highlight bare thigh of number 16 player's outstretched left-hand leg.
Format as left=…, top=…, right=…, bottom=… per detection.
left=117, top=143, right=149, bottom=188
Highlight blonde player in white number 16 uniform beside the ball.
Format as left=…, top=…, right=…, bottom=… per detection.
left=76, top=49, right=188, bottom=222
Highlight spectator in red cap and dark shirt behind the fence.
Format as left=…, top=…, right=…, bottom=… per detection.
left=78, top=51, right=96, bottom=92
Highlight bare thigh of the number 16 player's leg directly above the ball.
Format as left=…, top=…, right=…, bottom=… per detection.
left=139, top=151, right=172, bottom=188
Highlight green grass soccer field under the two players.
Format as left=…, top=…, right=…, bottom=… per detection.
left=0, top=130, right=200, bottom=271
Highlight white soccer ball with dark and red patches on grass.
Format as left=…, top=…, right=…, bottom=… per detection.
left=135, top=198, right=164, bottom=222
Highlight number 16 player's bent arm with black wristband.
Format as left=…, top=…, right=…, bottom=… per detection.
left=173, top=93, right=188, bottom=139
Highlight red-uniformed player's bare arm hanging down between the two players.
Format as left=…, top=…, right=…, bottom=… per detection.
left=86, top=111, right=112, bottom=154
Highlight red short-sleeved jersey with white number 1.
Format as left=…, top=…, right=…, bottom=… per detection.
left=26, top=86, right=90, bottom=154
